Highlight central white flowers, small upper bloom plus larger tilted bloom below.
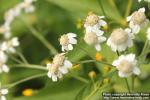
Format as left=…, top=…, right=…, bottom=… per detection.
left=47, top=33, right=77, bottom=82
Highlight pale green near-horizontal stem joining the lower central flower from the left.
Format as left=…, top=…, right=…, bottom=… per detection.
left=9, top=64, right=47, bottom=71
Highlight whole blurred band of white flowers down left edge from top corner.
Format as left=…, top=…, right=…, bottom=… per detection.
left=0, top=0, right=34, bottom=73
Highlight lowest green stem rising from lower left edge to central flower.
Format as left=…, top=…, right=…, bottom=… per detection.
left=3, top=73, right=47, bottom=88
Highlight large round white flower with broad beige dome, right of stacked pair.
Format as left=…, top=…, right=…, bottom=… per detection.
left=107, top=28, right=133, bottom=51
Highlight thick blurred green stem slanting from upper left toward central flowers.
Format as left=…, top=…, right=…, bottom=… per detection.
left=21, top=18, right=58, bottom=55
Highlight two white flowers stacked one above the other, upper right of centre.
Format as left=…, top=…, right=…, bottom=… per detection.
left=84, top=13, right=107, bottom=51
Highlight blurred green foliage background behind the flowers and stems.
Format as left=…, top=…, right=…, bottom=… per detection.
left=0, top=0, right=150, bottom=100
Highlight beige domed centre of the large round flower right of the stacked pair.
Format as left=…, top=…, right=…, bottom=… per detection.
left=111, top=28, right=128, bottom=45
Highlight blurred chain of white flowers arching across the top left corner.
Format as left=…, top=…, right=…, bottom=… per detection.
left=0, top=0, right=34, bottom=39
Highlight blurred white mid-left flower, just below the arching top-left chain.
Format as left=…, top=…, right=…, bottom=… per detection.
left=1, top=37, right=19, bottom=53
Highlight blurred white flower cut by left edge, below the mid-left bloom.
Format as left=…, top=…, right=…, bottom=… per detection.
left=0, top=50, right=9, bottom=73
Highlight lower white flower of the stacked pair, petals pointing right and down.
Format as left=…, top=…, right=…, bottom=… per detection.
left=84, top=29, right=106, bottom=51
